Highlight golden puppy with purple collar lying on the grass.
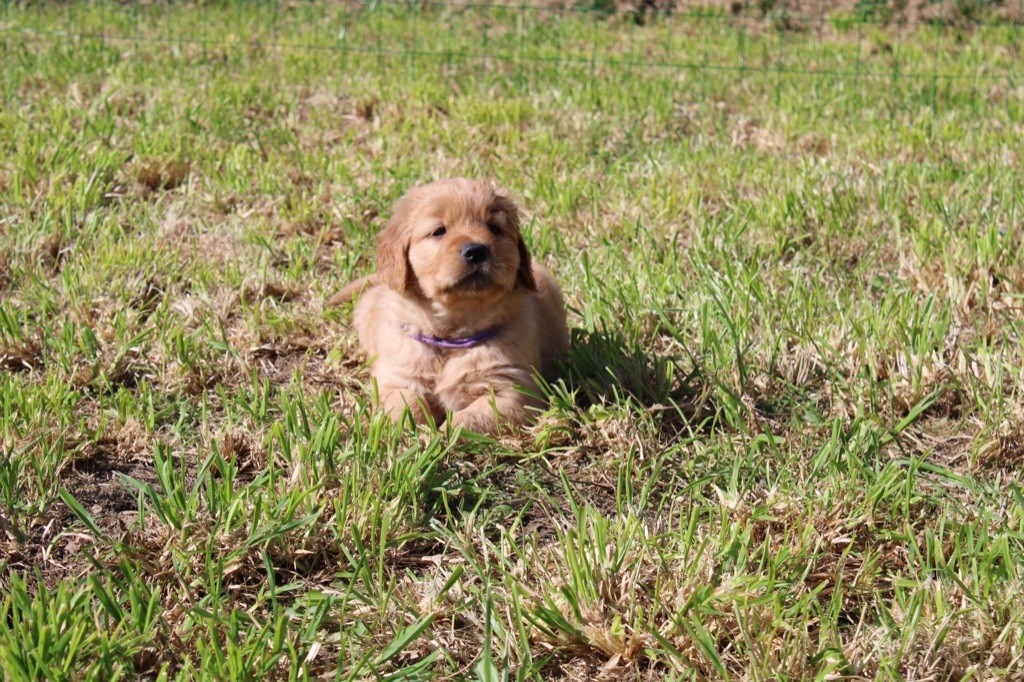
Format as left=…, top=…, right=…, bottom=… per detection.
left=328, top=178, right=568, bottom=433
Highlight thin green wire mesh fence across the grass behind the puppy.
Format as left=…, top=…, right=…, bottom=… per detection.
left=0, top=0, right=1024, bottom=116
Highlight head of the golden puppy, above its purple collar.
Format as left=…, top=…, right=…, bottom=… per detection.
left=377, top=178, right=537, bottom=304
